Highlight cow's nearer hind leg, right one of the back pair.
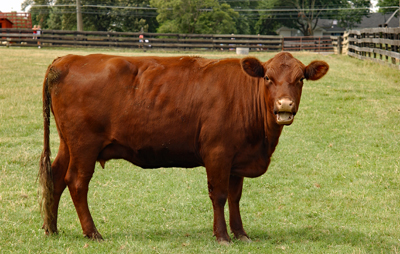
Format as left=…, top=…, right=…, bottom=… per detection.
left=66, top=149, right=103, bottom=239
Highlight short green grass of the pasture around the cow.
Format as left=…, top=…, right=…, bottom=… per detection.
left=0, top=47, right=400, bottom=253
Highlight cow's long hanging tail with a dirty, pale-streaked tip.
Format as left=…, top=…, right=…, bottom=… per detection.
left=38, top=66, right=57, bottom=234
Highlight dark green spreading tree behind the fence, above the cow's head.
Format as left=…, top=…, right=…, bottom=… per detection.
left=257, top=0, right=371, bottom=36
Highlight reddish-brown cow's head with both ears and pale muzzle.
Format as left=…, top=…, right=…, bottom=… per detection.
left=241, top=52, right=329, bottom=125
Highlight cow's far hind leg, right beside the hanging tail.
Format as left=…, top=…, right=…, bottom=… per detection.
left=43, top=138, right=70, bottom=234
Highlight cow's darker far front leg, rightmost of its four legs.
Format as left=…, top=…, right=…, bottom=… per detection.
left=228, top=175, right=251, bottom=242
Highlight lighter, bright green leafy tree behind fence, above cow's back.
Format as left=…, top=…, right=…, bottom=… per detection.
left=150, top=0, right=239, bottom=34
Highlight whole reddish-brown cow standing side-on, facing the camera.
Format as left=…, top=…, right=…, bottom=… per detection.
left=40, top=52, right=329, bottom=244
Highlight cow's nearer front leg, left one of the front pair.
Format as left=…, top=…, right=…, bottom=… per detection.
left=206, top=163, right=231, bottom=245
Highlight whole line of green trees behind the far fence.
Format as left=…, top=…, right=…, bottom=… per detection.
left=22, top=0, right=371, bottom=35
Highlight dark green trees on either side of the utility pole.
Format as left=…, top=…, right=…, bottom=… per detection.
left=24, top=0, right=158, bottom=32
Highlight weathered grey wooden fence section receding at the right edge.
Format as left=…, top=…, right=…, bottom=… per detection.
left=332, top=28, right=400, bottom=70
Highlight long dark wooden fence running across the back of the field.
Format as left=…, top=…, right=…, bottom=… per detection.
left=0, top=29, right=333, bottom=52
